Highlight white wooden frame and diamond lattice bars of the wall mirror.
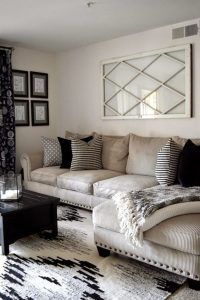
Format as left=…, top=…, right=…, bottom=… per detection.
left=101, top=44, right=192, bottom=119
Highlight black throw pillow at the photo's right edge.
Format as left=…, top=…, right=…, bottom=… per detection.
left=178, top=140, right=200, bottom=187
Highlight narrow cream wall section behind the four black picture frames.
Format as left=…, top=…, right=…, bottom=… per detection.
left=12, top=47, right=57, bottom=171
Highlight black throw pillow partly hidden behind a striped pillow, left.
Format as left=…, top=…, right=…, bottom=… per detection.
left=58, top=136, right=93, bottom=169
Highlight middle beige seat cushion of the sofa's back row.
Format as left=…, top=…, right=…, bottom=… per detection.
left=57, top=169, right=121, bottom=195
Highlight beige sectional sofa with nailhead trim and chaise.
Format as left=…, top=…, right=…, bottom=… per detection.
left=21, top=134, right=200, bottom=288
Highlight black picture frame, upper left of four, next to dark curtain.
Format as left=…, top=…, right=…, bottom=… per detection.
left=12, top=69, right=29, bottom=98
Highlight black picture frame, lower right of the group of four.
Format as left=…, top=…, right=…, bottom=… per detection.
left=31, top=100, right=49, bottom=126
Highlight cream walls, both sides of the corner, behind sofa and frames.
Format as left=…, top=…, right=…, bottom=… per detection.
left=9, top=20, right=200, bottom=170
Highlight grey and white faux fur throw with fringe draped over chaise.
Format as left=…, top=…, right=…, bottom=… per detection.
left=112, top=185, right=200, bottom=246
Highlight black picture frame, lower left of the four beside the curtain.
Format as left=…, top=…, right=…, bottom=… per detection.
left=15, top=99, right=30, bottom=126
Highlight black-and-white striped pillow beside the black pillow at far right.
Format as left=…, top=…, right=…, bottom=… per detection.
left=155, top=138, right=181, bottom=185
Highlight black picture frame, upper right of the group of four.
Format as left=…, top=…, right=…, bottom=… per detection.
left=30, top=71, right=48, bottom=98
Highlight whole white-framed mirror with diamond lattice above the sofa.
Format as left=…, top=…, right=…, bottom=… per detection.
left=101, top=44, right=192, bottom=119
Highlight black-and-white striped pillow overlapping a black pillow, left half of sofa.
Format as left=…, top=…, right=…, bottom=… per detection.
left=71, top=135, right=102, bottom=171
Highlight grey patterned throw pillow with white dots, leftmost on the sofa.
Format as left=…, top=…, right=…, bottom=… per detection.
left=41, top=136, right=62, bottom=167
